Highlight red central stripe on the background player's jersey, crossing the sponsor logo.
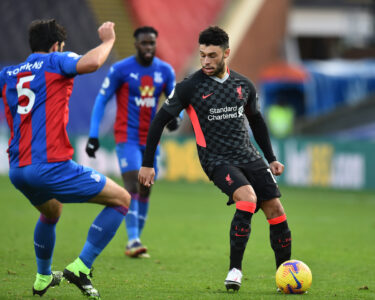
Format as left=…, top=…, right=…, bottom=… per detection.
left=138, top=75, right=156, bottom=145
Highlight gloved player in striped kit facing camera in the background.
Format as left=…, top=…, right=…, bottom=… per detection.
left=86, top=26, right=181, bottom=257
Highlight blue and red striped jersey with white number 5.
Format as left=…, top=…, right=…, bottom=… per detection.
left=0, top=52, right=80, bottom=167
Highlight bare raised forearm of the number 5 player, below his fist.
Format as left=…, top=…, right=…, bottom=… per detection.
left=77, top=39, right=115, bottom=74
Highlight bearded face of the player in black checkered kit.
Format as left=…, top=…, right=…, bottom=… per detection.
left=199, top=45, right=230, bottom=78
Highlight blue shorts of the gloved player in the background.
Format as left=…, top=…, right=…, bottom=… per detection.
left=116, top=142, right=159, bottom=178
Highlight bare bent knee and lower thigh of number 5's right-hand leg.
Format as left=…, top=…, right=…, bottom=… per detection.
left=88, top=177, right=131, bottom=207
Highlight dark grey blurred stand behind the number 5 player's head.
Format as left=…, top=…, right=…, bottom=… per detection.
left=0, top=0, right=104, bottom=65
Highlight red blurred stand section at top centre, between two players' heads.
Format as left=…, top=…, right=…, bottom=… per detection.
left=127, top=0, right=229, bottom=75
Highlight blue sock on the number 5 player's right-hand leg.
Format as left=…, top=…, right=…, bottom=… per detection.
left=79, top=207, right=127, bottom=269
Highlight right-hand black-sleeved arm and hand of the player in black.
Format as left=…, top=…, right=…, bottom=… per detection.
left=245, top=90, right=284, bottom=175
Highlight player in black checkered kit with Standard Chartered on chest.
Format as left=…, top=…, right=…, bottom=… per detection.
left=138, top=26, right=291, bottom=290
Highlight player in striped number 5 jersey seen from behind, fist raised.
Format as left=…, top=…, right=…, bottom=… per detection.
left=0, top=19, right=130, bottom=299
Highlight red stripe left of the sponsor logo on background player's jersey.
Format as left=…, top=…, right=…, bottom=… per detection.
left=113, top=83, right=129, bottom=144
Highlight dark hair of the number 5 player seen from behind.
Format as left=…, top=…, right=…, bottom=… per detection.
left=29, top=19, right=66, bottom=52
